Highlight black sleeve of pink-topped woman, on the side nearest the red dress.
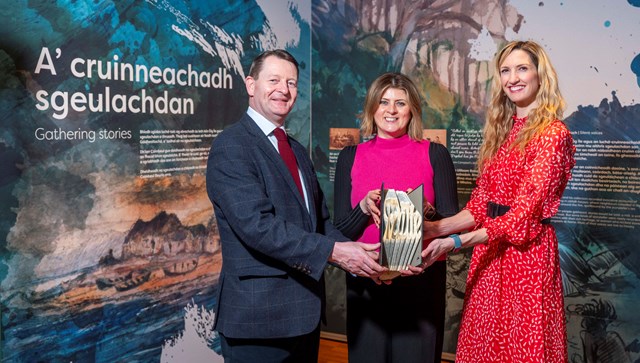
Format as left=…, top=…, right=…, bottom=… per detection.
left=429, top=142, right=459, bottom=220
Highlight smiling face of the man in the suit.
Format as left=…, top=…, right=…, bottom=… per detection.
left=245, top=56, right=298, bottom=126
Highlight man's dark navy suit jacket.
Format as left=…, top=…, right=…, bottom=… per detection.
left=207, top=114, right=347, bottom=338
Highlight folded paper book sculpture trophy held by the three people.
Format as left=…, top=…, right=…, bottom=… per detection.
left=380, top=184, right=424, bottom=280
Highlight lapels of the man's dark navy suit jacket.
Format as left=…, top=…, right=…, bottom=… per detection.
left=241, top=114, right=315, bottom=220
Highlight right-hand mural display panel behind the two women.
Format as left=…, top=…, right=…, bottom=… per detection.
left=312, top=0, right=640, bottom=363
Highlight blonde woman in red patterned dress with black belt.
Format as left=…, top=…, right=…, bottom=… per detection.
left=416, top=41, right=575, bottom=363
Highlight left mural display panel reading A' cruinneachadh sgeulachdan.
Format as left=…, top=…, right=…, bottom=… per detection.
left=0, top=0, right=311, bottom=362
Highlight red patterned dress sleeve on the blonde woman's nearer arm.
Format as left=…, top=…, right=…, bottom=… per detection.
left=484, top=121, right=575, bottom=245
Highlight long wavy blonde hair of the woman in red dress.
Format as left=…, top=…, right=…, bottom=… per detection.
left=478, top=41, right=565, bottom=172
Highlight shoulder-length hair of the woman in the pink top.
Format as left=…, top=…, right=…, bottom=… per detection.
left=358, top=73, right=422, bottom=141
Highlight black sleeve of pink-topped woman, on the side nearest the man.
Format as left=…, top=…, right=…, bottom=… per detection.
left=333, top=145, right=370, bottom=240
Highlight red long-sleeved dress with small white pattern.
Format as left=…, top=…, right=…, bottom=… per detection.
left=456, top=117, right=575, bottom=363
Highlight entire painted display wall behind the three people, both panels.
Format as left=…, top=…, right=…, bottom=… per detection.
left=0, top=0, right=640, bottom=362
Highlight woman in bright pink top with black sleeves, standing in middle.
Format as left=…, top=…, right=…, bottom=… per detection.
left=334, top=73, right=458, bottom=363
